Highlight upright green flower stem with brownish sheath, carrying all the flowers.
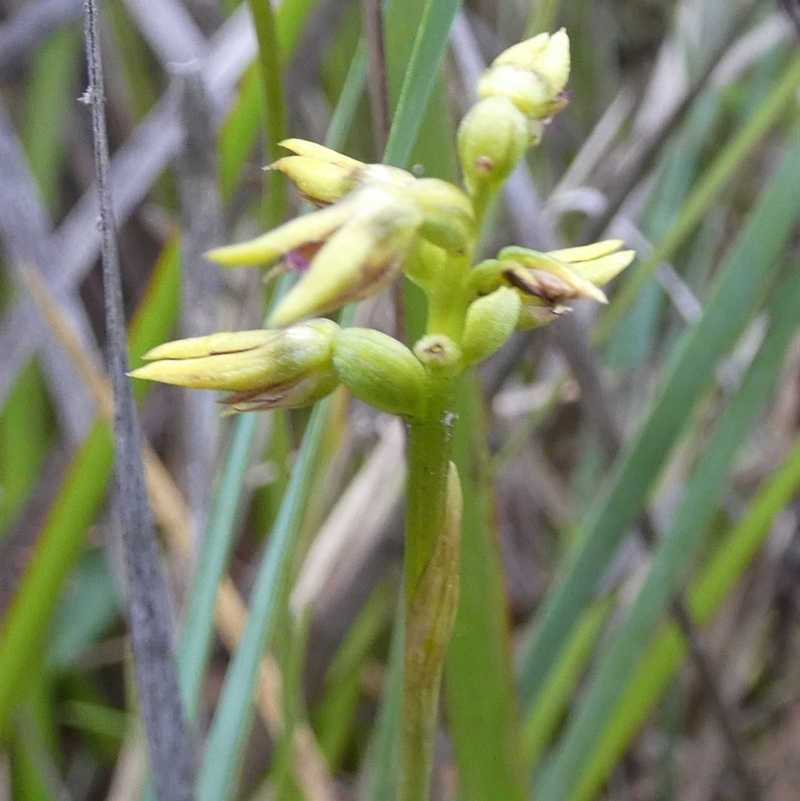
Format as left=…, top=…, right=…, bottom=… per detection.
left=398, top=173, right=506, bottom=801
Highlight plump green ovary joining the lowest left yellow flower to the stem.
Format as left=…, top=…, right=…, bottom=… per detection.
left=332, top=328, right=425, bottom=417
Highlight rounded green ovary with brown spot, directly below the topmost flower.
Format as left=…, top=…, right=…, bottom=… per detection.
left=458, top=96, right=530, bottom=196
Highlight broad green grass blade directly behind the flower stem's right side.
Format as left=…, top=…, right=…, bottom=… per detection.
left=445, top=376, right=525, bottom=801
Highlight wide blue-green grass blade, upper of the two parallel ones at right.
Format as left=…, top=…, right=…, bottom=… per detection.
left=519, top=126, right=800, bottom=709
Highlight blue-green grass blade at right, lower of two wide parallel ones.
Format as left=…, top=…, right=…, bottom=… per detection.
left=537, top=256, right=800, bottom=801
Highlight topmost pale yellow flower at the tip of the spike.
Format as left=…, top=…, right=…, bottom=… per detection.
left=478, top=28, right=569, bottom=120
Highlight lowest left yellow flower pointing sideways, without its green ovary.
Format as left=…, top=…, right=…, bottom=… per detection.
left=130, top=320, right=339, bottom=412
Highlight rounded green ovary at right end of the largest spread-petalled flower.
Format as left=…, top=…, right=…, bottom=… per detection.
left=408, top=178, right=475, bottom=253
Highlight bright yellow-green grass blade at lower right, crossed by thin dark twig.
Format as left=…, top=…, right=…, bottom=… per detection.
left=571, top=437, right=800, bottom=801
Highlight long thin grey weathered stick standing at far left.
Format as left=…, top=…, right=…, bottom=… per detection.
left=84, top=0, right=195, bottom=801
